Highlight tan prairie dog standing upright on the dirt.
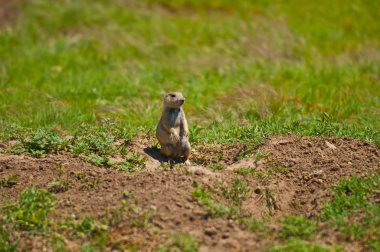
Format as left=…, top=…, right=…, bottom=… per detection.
left=156, top=92, right=191, bottom=163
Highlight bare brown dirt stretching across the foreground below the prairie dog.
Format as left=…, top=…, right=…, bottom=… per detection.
left=0, top=136, right=380, bottom=251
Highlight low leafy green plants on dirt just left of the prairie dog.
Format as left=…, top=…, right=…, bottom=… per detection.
left=2, top=121, right=145, bottom=170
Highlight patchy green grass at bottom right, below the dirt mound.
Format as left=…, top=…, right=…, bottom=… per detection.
left=197, top=176, right=380, bottom=251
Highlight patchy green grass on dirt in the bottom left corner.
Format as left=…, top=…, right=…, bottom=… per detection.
left=0, top=187, right=157, bottom=252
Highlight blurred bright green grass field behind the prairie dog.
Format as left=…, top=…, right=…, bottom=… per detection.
left=0, top=0, right=380, bottom=145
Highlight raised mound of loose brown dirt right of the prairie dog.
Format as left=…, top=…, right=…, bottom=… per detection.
left=263, top=136, right=380, bottom=215
